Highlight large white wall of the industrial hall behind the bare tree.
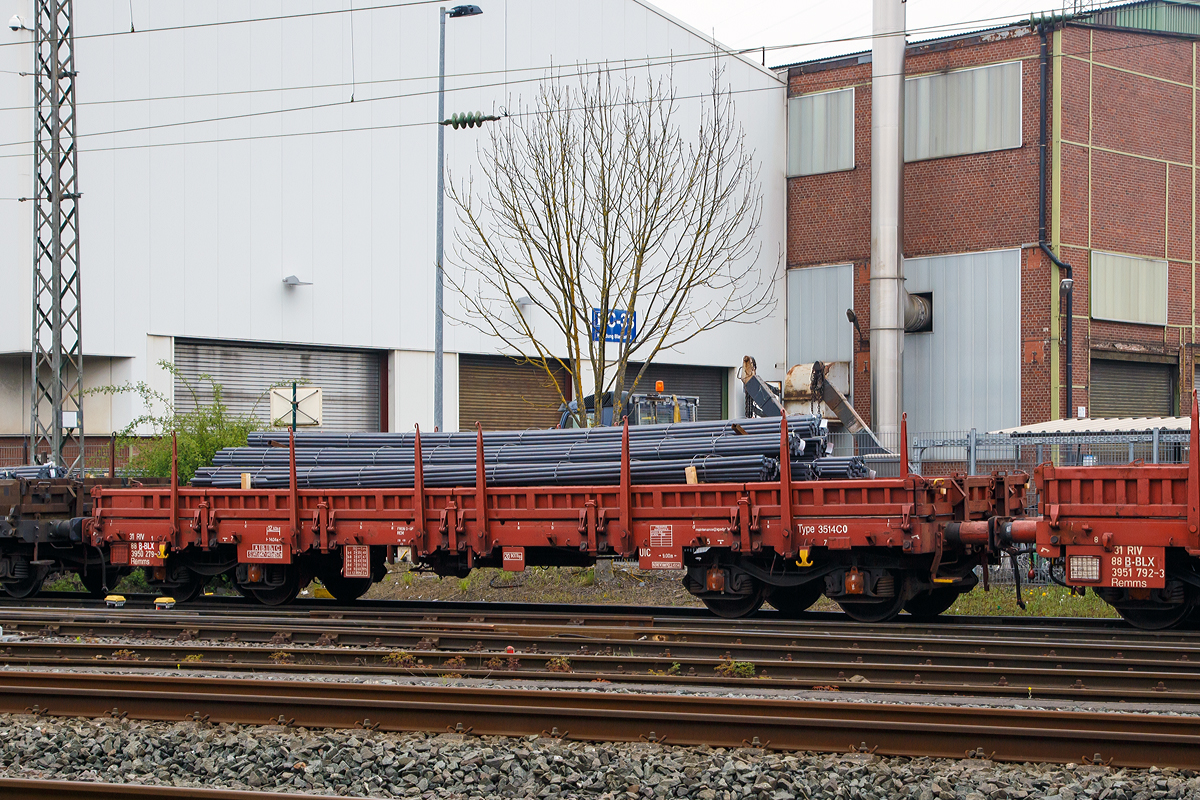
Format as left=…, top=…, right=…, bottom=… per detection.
left=0, top=0, right=786, bottom=435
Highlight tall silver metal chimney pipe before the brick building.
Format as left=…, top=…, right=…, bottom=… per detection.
left=871, top=0, right=910, bottom=446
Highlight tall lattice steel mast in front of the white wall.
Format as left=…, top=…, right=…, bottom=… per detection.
left=30, top=0, right=84, bottom=469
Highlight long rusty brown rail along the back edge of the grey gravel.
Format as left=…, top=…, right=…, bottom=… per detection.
left=0, top=672, right=1200, bottom=768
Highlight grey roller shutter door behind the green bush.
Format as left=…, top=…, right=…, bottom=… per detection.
left=175, top=339, right=380, bottom=431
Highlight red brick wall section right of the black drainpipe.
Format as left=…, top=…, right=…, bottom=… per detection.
left=1060, top=28, right=1196, bottom=411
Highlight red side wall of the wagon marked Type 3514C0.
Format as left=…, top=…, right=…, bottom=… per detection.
left=85, top=422, right=1026, bottom=567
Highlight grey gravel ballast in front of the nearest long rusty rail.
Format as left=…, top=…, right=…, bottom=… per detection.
left=0, top=715, right=1200, bottom=800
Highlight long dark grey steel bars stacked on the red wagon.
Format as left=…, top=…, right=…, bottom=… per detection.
left=192, top=416, right=860, bottom=488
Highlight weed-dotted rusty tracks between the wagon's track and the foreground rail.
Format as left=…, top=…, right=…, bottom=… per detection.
left=7, top=599, right=1200, bottom=703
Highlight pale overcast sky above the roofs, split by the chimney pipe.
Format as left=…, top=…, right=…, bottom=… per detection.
left=649, top=0, right=1108, bottom=66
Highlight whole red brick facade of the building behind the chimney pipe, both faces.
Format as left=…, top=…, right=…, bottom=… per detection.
left=787, top=20, right=1196, bottom=423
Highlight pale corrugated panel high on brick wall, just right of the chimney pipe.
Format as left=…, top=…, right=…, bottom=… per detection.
left=904, top=61, right=1021, bottom=161
